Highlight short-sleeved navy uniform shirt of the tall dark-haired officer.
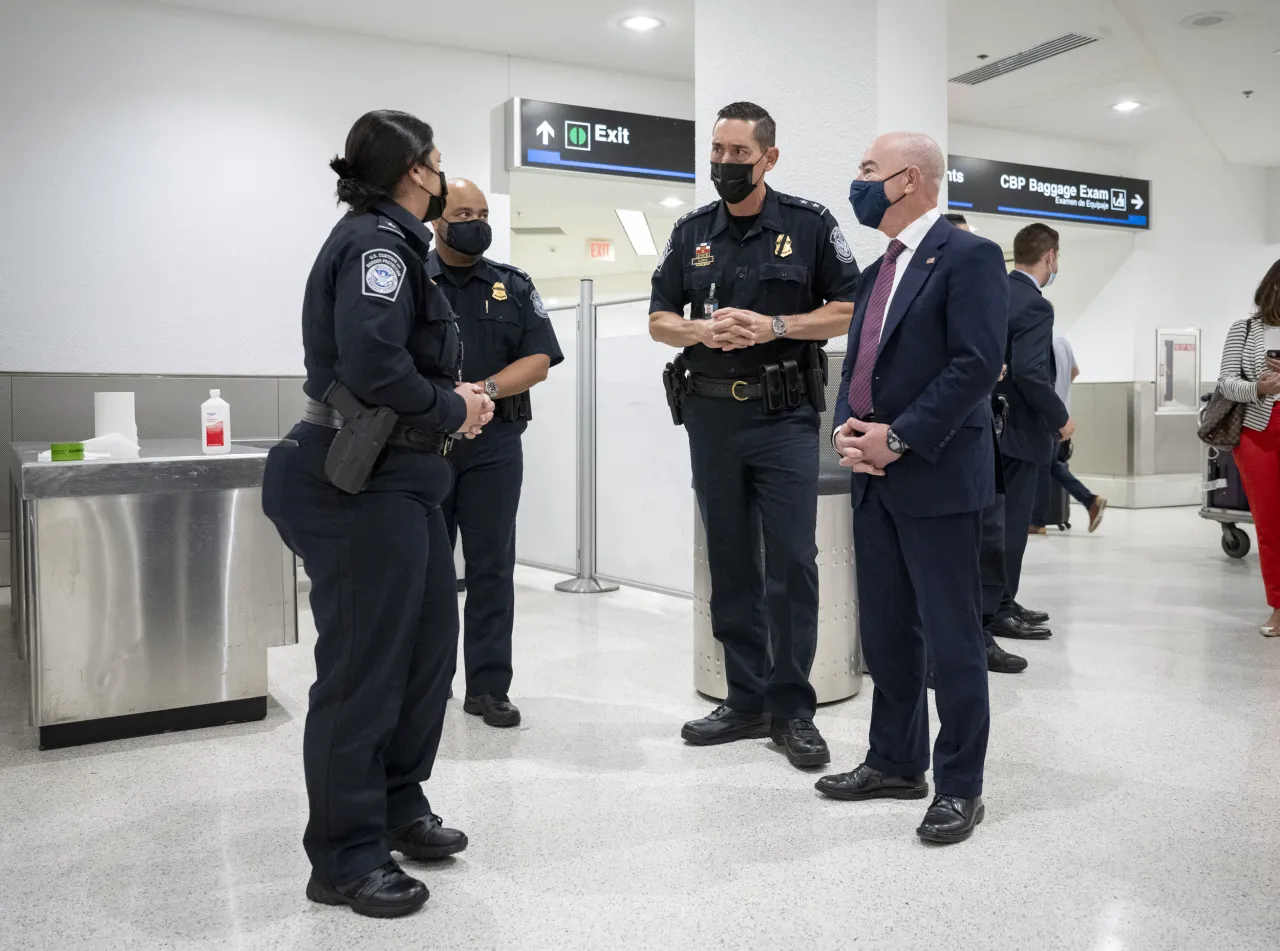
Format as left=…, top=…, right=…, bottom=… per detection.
left=649, top=187, right=858, bottom=379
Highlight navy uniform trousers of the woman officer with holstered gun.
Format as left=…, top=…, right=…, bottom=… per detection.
left=262, top=424, right=458, bottom=884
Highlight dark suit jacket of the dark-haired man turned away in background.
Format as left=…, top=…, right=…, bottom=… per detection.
left=996, top=271, right=1068, bottom=466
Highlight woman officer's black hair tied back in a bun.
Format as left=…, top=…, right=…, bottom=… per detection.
left=329, top=109, right=435, bottom=211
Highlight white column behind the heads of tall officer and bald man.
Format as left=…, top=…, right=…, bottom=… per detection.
left=694, top=0, right=947, bottom=265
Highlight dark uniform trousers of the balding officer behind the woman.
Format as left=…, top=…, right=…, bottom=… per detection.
left=442, top=422, right=525, bottom=698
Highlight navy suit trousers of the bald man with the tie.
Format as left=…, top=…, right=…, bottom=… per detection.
left=854, top=476, right=991, bottom=799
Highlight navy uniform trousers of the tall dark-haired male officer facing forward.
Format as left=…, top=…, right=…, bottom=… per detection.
left=685, top=397, right=818, bottom=719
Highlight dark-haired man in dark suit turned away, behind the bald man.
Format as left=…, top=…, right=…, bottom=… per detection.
left=987, top=221, right=1075, bottom=640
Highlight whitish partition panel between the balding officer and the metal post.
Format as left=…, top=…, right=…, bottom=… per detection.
left=516, top=307, right=577, bottom=573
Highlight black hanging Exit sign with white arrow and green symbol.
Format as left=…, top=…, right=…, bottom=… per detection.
left=506, top=99, right=694, bottom=183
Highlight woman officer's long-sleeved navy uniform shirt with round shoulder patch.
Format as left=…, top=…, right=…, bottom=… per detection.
left=302, top=201, right=467, bottom=433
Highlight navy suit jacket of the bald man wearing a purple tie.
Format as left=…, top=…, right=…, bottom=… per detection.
left=833, top=218, right=1009, bottom=517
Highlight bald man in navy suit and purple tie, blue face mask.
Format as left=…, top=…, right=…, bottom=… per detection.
left=818, top=132, right=1009, bottom=842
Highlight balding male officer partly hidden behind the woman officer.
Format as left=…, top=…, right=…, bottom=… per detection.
left=426, top=179, right=564, bottom=727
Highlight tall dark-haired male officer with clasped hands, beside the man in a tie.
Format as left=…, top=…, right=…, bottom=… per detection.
left=649, top=102, right=858, bottom=767
